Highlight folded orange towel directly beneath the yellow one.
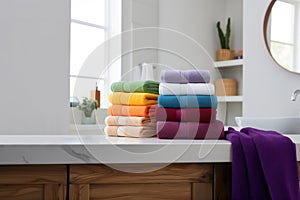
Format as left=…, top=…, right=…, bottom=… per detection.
left=108, top=105, right=157, bottom=117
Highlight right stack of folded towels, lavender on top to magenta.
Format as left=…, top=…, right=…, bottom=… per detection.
left=156, top=70, right=224, bottom=139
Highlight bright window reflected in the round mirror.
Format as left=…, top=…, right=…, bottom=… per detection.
left=270, top=1, right=297, bottom=69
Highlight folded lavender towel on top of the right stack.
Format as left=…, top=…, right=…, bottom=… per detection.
left=160, top=70, right=210, bottom=83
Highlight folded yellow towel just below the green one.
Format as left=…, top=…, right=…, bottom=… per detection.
left=109, top=92, right=158, bottom=106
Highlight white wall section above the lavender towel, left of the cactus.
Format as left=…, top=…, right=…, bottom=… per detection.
left=156, top=0, right=225, bottom=87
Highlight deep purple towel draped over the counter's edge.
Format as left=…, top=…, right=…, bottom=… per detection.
left=226, top=128, right=300, bottom=200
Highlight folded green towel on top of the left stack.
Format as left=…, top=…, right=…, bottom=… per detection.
left=110, top=80, right=159, bottom=94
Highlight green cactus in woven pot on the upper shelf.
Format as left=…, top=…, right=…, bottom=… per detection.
left=217, top=17, right=234, bottom=61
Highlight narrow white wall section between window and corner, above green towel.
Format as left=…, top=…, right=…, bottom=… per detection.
left=122, top=0, right=159, bottom=80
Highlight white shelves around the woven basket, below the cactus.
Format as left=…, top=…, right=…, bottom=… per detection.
left=214, top=59, right=243, bottom=126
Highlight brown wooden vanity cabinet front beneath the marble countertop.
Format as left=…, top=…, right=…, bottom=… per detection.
left=0, top=163, right=231, bottom=200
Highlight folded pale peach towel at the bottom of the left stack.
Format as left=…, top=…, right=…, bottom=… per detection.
left=104, top=126, right=156, bottom=138
